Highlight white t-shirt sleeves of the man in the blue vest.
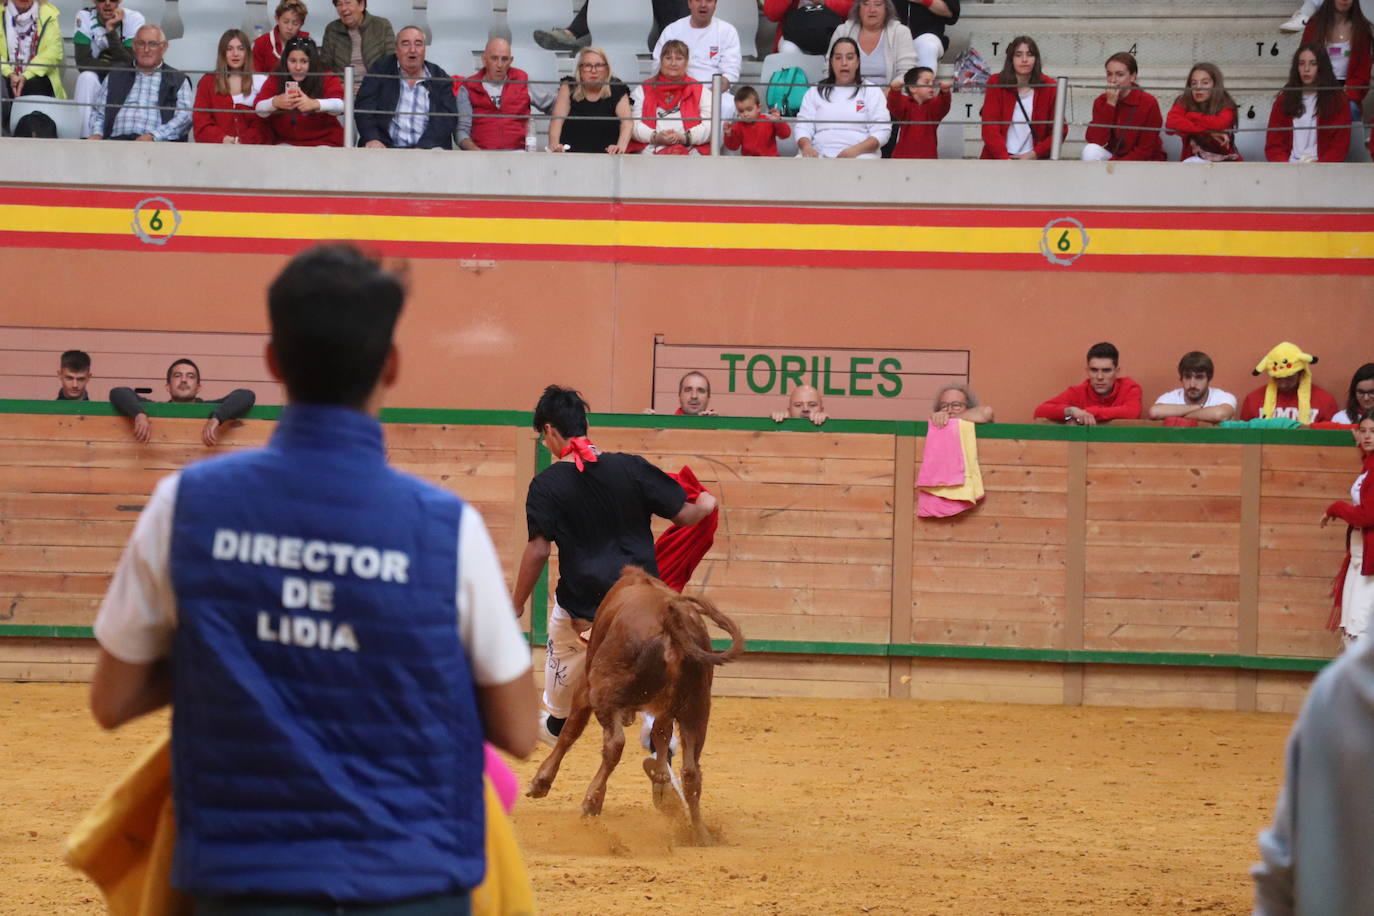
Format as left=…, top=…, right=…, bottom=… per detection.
left=95, top=474, right=530, bottom=687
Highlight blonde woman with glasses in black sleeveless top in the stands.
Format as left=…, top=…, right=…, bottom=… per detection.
left=548, top=48, right=633, bottom=154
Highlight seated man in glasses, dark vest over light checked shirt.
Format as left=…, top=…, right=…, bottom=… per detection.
left=87, top=25, right=194, bottom=143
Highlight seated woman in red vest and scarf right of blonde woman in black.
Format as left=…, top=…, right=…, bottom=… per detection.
left=628, top=40, right=712, bottom=155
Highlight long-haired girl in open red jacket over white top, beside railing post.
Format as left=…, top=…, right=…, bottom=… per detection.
left=981, top=36, right=1069, bottom=159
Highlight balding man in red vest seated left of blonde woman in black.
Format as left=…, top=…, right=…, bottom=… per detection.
left=453, top=38, right=555, bottom=150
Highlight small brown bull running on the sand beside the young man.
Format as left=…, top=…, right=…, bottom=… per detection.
left=528, top=566, right=745, bottom=842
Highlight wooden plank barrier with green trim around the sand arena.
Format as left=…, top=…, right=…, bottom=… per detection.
left=0, top=401, right=1358, bottom=710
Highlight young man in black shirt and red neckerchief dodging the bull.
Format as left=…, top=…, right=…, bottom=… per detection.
left=514, top=385, right=716, bottom=744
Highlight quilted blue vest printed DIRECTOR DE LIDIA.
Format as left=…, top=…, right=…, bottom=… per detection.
left=170, top=405, right=485, bottom=902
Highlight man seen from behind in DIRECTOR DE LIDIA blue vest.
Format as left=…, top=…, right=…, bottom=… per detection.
left=91, top=241, right=537, bottom=916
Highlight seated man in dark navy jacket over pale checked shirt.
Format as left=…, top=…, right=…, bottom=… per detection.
left=353, top=26, right=458, bottom=150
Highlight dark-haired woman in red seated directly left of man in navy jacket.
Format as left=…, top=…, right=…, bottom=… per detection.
left=254, top=36, right=344, bottom=147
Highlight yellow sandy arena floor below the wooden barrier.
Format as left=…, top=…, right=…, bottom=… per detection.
left=0, top=684, right=1292, bottom=916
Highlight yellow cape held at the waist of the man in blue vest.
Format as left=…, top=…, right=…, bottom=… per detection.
left=67, top=735, right=536, bottom=916
